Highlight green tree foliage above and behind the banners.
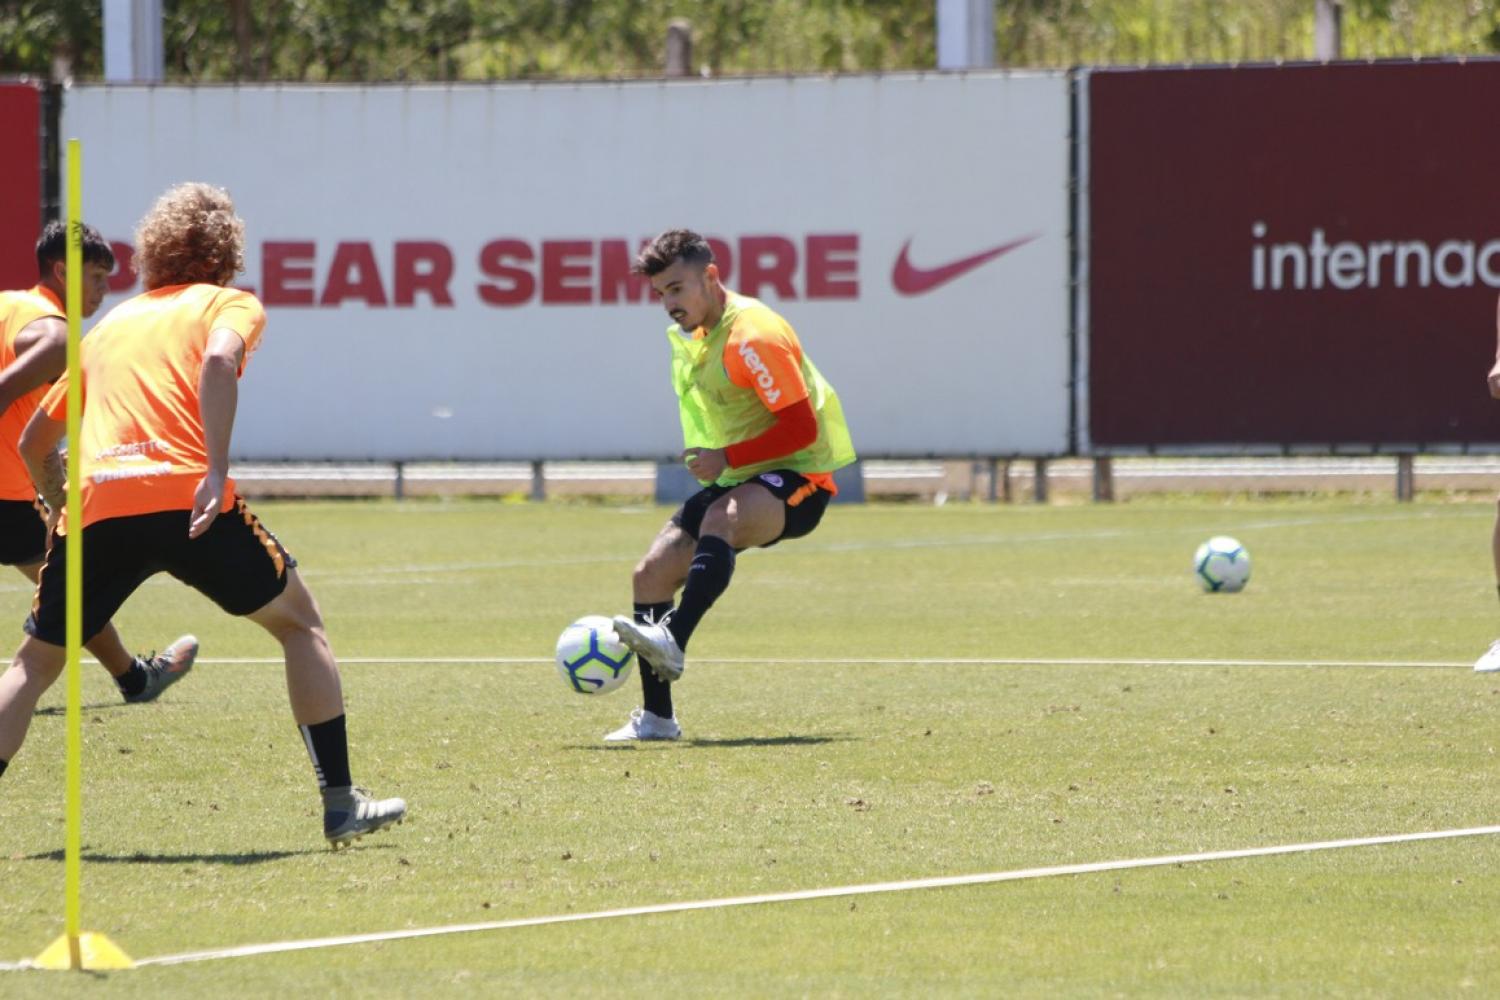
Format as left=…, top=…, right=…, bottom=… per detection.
left=0, top=0, right=1500, bottom=81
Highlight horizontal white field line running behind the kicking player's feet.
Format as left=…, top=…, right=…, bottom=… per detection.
left=184, top=657, right=1473, bottom=669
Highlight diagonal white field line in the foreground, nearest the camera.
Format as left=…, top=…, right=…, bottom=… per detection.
left=61, top=826, right=1500, bottom=969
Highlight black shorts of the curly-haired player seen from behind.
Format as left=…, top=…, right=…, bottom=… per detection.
left=26, top=498, right=297, bottom=646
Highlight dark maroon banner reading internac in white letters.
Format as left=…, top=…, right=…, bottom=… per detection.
left=1088, top=61, right=1500, bottom=448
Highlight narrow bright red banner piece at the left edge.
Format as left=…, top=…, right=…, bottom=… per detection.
left=0, top=82, right=42, bottom=288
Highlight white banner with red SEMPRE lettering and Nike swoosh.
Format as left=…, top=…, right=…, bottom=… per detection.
left=63, top=73, right=1070, bottom=460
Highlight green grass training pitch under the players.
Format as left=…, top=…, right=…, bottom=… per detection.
left=0, top=498, right=1500, bottom=997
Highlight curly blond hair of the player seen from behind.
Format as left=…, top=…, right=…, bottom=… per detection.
left=134, top=183, right=245, bottom=291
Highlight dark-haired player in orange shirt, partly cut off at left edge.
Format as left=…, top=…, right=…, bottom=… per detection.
left=0, top=222, right=198, bottom=705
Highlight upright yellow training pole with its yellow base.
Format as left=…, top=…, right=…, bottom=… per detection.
left=35, top=139, right=134, bottom=969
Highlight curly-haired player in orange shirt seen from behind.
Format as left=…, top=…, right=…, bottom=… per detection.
left=0, top=184, right=407, bottom=849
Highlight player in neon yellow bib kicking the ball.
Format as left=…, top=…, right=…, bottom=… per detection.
left=605, top=229, right=855, bottom=741
